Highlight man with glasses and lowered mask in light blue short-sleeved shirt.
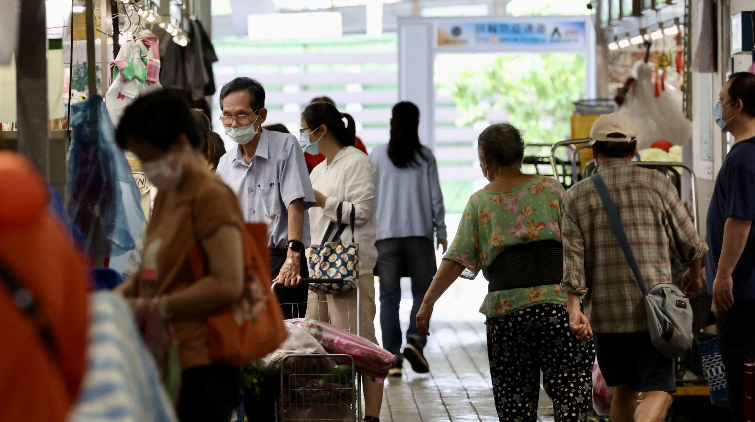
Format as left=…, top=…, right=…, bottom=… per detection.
left=217, top=78, right=315, bottom=318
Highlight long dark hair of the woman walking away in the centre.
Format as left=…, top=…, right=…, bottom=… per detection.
left=388, top=101, right=427, bottom=169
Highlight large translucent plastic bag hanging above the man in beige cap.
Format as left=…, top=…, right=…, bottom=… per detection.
left=619, top=61, right=692, bottom=150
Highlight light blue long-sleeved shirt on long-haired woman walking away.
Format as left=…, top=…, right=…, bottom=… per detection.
left=370, top=145, right=447, bottom=240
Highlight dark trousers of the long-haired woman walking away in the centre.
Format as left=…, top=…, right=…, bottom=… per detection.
left=375, top=237, right=437, bottom=366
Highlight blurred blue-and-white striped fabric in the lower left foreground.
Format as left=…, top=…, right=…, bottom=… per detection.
left=70, top=291, right=178, bottom=422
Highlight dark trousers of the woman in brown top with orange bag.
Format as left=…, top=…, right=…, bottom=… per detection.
left=178, top=364, right=241, bottom=422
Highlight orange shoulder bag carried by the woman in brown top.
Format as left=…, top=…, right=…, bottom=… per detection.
left=186, top=224, right=288, bottom=366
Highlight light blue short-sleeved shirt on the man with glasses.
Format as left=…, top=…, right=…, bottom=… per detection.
left=217, top=129, right=315, bottom=249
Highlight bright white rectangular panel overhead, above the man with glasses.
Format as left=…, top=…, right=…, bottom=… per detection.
left=247, top=12, right=343, bottom=41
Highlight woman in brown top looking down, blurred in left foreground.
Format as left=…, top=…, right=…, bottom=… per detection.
left=116, top=91, right=244, bottom=422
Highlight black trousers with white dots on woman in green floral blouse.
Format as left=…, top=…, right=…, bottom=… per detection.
left=487, top=304, right=595, bottom=422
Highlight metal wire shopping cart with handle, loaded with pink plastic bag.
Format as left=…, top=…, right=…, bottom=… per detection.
left=273, top=278, right=362, bottom=422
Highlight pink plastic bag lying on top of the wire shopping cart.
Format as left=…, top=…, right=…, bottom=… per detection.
left=287, top=318, right=393, bottom=383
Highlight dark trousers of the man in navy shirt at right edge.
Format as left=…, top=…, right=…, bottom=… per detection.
left=718, top=299, right=755, bottom=422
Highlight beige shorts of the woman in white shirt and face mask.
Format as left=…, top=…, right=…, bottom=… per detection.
left=307, top=273, right=379, bottom=345
